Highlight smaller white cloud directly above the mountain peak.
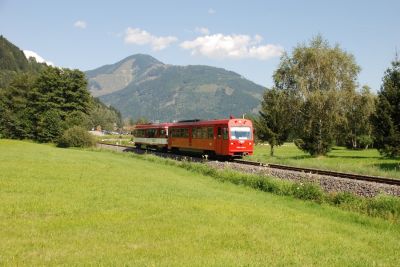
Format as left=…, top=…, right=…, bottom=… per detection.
left=124, top=27, right=178, bottom=51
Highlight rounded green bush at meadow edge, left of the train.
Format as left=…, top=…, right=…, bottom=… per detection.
left=57, top=126, right=96, bottom=147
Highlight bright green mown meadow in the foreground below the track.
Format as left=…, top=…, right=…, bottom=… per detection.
left=0, top=140, right=400, bottom=266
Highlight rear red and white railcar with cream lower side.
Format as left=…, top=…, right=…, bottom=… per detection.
left=132, top=123, right=171, bottom=150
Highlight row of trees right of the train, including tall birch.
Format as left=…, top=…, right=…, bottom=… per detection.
left=253, top=36, right=400, bottom=157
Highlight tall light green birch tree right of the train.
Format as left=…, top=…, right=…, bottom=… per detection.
left=274, top=36, right=360, bottom=155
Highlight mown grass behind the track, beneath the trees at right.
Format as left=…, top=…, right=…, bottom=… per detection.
left=248, top=143, right=400, bottom=179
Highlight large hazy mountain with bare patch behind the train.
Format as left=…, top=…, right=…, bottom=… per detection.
left=86, top=54, right=265, bottom=121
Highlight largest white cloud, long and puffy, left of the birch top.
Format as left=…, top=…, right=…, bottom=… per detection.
left=180, top=34, right=284, bottom=60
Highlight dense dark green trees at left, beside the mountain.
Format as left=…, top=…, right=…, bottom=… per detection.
left=0, top=65, right=122, bottom=142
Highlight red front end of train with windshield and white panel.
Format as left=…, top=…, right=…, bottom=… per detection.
left=228, top=119, right=254, bottom=157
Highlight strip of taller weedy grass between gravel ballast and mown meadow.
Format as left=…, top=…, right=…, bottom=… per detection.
left=133, top=154, right=400, bottom=223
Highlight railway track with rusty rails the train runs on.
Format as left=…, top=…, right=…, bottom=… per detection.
left=97, top=143, right=400, bottom=186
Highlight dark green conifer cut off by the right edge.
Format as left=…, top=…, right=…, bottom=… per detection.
left=372, top=57, right=400, bottom=157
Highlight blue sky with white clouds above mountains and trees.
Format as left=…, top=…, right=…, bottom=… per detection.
left=0, top=0, right=400, bottom=91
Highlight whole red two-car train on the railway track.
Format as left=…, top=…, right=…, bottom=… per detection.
left=133, top=119, right=254, bottom=157
